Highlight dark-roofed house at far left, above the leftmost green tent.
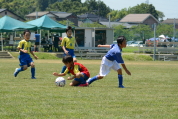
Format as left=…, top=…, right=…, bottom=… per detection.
left=0, top=9, right=25, bottom=21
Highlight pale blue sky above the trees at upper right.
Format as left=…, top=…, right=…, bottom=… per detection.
left=81, top=0, right=178, bottom=20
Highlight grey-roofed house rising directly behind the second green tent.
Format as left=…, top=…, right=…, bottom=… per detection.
left=25, top=11, right=78, bottom=26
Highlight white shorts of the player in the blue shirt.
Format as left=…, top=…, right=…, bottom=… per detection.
left=99, top=57, right=121, bottom=76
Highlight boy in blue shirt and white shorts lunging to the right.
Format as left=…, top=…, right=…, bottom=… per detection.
left=87, top=36, right=131, bottom=88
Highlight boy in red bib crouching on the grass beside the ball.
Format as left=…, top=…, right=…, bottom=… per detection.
left=53, top=56, right=90, bottom=86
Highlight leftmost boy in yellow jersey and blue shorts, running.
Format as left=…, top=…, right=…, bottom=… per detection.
left=14, top=30, right=38, bottom=79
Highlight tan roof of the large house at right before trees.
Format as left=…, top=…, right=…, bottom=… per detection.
left=120, top=14, right=159, bottom=23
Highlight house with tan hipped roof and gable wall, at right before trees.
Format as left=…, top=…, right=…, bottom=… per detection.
left=119, top=14, right=159, bottom=28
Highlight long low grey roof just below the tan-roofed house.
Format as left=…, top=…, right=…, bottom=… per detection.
left=100, top=22, right=137, bottom=28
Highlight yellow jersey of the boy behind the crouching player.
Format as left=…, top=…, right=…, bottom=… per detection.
left=61, top=37, right=75, bottom=49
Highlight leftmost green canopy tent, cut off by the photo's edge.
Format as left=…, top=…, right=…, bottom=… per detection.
left=0, top=16, right=37, bottom=51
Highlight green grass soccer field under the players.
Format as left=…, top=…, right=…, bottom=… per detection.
left=0, top=59, right=178, bottom=119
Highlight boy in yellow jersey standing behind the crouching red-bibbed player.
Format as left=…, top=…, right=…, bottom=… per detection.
left=61, top=26, right=77, bottom=73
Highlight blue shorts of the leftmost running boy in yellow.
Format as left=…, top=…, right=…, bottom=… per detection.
left=19, top=53, right=33, bottom=67
